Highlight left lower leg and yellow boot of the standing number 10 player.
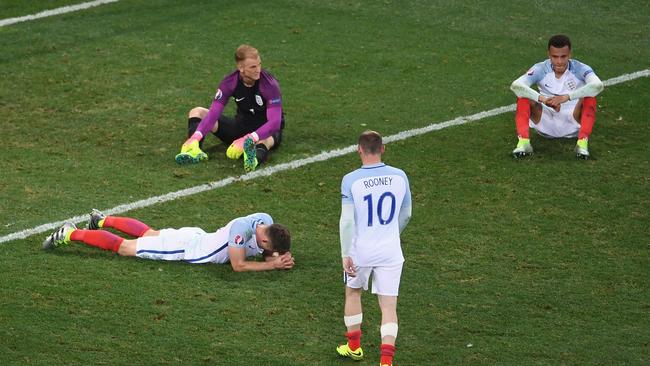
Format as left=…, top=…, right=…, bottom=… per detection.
left=336, top=286, right=363, bottom=361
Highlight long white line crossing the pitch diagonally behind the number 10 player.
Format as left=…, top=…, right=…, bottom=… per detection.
left=0, top=69, right=650, bottom=243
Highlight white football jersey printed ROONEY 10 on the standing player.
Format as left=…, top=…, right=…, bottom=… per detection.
left=341, top=163, right=411, bottom=267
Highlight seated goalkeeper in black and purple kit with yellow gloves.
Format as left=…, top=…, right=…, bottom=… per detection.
left=176, top=44, right=284, bottom=171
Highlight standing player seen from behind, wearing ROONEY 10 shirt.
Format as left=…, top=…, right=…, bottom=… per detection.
left=336, top=131, right=411, bottom=365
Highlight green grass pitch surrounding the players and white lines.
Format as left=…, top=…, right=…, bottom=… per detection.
left=0, top=0, right=650, bottom=365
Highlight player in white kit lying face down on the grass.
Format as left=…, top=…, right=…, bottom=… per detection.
left=43, top=210, right=294, bottom=272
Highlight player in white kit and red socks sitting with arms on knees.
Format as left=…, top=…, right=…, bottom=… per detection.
left=510, top=34, right=603, bottom=159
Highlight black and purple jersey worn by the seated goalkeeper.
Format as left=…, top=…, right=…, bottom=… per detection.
left=197, top=70, right=282, bottom=139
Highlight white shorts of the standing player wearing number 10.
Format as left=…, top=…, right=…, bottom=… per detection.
left=343, top=263, right=404, bottom=296
